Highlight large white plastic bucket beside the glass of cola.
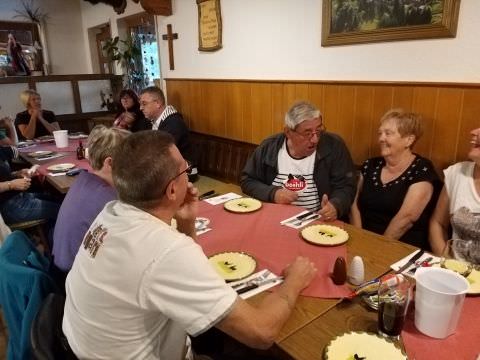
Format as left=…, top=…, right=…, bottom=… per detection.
left=415, top=267, right=469, bottom=339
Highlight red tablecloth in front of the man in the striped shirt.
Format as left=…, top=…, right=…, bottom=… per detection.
left=198, top=201, right=349, bottom=298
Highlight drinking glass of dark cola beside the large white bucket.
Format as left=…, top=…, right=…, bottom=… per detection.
left=378, top=274, right=412, bottom=339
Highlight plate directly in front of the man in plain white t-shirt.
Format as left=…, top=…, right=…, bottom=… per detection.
left=208, top=252, right=257, bottom=281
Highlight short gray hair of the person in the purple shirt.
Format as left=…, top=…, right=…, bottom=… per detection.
left=87, top=125, right=131, bottom=170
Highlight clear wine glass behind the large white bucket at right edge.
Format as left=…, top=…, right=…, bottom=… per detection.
left=440, top=239, right=480, bottom=277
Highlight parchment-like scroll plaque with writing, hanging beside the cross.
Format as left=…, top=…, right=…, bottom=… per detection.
left=197, top=0, right=222, bottom=51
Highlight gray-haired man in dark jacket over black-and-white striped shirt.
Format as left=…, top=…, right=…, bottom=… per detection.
left=240, top=102, right=355, bottom=221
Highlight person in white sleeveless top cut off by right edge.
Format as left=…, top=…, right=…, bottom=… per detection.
left=430, top=128, right=480, bottom=255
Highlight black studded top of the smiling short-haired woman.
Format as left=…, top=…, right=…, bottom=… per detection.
left=358, top=154, right=440, bottom=249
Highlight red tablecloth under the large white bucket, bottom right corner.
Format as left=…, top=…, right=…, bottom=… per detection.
left=402, top=296, right=480, bottom=360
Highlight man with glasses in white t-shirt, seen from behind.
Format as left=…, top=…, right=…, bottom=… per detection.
left=63, top=131, right=316, bottom=359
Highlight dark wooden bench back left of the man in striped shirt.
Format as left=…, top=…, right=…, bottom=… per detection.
left=190, top=131, right=257, bottom=184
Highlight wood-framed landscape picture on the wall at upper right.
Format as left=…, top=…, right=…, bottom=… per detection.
left=322, top=0, right=460, bottom=46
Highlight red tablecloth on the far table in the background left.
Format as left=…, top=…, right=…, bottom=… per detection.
left=19, top=139, right=92, bottom=176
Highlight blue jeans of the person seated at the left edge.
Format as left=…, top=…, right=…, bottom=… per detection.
left=0, top=192, right=60, bottom=224
